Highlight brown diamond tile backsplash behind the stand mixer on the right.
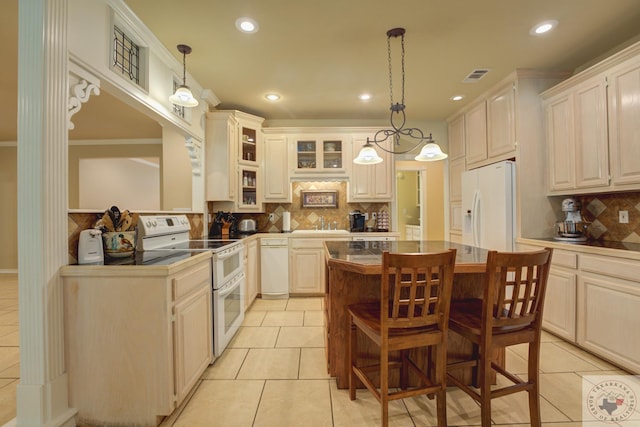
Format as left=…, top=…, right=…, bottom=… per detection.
left=580, top=192, right=640, bottom=243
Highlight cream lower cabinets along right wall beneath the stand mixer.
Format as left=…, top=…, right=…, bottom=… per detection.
left=518, top=241, right=640, bottom=374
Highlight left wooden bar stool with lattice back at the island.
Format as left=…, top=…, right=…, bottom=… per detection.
left=349, top=249, right=456, bottom=427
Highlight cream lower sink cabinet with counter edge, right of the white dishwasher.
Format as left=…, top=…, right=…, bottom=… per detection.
left=289, top=236, right=351, bottom=295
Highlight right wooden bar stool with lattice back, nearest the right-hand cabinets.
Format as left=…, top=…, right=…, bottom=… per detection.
left=447, top=248, right=553, bottom=427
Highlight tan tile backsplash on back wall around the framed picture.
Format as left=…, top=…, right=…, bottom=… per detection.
left=230, top=181, right=390, bottom=233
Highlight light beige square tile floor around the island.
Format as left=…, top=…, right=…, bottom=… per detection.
left=0, top=274, right=640, bottom=427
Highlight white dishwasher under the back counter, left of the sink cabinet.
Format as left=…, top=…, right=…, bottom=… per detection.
left=260, top=237, right=289, bottom=299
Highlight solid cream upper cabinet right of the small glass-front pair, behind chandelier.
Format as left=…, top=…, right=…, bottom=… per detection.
left=347, top=135, right=394, bottom=203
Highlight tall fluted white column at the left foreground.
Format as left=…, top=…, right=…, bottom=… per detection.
left=16, top=0, right=75, bottom=426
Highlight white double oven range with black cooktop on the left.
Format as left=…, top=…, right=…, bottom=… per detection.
left=137, top=215, right=245, bottom=357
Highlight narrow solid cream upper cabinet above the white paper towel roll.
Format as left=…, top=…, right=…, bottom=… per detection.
left=264, top=134, right=292, bottom=203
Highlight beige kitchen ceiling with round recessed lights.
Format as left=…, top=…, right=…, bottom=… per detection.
left=0, top=0, right=640, bottom=140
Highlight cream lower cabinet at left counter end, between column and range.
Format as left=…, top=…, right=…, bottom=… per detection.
left=61, top=252, right=213, bottom=426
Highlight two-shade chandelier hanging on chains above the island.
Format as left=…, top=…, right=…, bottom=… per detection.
left=353, top=28, right=447, bottom=165
